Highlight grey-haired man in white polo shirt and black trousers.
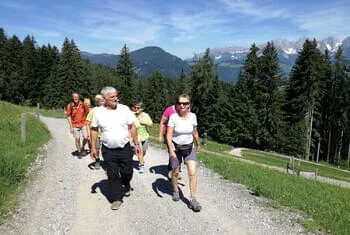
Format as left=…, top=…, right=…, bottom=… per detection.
left=90, top=87, right=140, bottom=210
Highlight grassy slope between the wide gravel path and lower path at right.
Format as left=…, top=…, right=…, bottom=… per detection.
left=198, top=152, right=350, bottom=235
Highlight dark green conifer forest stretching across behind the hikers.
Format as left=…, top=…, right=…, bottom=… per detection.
left=0, top=29, right=350, bottom=165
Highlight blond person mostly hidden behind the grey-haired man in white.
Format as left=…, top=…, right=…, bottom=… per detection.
left=86, top=95, right=105, bottom=170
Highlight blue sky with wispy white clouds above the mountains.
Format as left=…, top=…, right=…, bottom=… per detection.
left=0, top=0, right=350, bottom=58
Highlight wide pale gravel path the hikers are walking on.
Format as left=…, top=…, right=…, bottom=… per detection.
left=0, top=117, right=305, bottom=234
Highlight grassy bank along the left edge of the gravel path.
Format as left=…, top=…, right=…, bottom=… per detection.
left=0, top=101, right=50, bottom=218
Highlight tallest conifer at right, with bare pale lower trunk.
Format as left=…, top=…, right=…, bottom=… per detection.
left=287, top=40, right=324, bottom=160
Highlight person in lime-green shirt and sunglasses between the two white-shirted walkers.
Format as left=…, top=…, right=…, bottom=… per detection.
left=134, top=102, right=153, bottom=173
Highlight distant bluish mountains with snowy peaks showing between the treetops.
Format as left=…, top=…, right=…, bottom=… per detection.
left=81, top=37, right=350, bottom=82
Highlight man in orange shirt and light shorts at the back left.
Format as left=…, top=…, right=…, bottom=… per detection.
left=66, top=93, right=89, bottom=159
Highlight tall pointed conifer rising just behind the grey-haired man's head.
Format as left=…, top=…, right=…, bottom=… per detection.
left=116, top=44, right=136, bottom=104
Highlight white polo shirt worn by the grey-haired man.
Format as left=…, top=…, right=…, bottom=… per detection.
left=91, top=104, right=135, bottom=148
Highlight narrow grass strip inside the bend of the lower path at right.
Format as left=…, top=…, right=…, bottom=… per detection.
left=242, top=150, right=350, bottom=182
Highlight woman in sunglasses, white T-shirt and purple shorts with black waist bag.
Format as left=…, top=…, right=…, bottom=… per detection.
left=167, top=94, right=202, bottom=212
